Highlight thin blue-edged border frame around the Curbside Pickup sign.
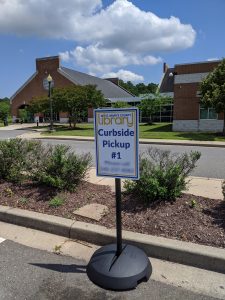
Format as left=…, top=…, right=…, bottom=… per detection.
left=94, top=107, right=140, bottom=180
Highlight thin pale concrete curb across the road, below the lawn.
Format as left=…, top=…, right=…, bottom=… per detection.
left=18, top=131, right=225, bottom=148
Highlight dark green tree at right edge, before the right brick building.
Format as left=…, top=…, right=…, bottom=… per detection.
left=200, top=59, right=225, bottom=135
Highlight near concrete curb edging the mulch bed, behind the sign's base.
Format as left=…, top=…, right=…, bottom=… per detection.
left=0, top=206, right=225, bottom=273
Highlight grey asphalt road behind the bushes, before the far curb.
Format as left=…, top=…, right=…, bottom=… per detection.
left=0, top=130, right=225, bottom=179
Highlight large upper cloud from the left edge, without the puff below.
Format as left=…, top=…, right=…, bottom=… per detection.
left=0, top=0, right=196, bottom=53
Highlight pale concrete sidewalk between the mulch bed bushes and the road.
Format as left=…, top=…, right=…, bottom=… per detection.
left=87, top=168, right=223, bottom=200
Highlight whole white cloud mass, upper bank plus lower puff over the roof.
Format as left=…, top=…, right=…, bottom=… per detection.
left=0, top=0, right=196, bottom=81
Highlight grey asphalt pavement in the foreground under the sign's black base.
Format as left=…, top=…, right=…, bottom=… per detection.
left=0, top=239, right=220, bottom=300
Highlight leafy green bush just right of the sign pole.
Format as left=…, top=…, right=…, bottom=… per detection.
left=124, top=148, right=201, bottom=202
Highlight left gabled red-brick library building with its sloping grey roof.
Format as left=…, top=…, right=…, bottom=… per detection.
left=10, top=56, right=134, bottom=123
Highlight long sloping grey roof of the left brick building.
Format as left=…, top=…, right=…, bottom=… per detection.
left=59, top=67, right=133, bottom=98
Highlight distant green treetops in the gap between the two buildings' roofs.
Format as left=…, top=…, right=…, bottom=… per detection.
left=119, top=80, right=158, bottom=96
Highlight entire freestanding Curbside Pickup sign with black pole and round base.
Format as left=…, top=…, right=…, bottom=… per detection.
left=87, top=108, right=152, bottom=290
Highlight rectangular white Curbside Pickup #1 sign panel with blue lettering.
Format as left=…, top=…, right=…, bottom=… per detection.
left=94, top=108, right=139, bottom=179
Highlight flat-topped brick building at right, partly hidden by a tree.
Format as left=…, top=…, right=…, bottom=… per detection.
left=159, top=61, right=223, bottom=131
